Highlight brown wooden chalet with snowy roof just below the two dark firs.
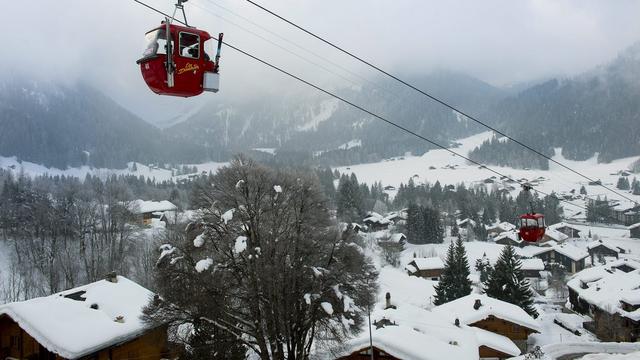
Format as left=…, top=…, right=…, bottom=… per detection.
left=432, top=294, right=540, bottom=357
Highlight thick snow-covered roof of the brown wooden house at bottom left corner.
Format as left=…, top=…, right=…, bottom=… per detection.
left=0, top=276, right=153, bottom=359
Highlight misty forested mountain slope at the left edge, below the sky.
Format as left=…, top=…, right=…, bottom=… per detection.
left=0, top=78, right=204, bottom=168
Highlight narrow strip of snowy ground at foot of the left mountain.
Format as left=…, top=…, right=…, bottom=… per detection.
left=0, top=156, right=227, bottom=182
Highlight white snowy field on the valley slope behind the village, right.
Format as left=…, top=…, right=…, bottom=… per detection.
left=337, top=132, right=640, bottom=218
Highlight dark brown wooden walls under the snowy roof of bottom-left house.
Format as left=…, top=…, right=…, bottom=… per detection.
left=0, top=315, right=168, bottom=360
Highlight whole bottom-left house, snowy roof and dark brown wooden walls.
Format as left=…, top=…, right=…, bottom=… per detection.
left=0, top=274, right=167, bottom=360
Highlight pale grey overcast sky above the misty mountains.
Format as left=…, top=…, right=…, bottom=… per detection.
left=0, top=0, right=640, bottom=122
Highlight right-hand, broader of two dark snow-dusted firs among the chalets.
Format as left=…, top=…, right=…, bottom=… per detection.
left=484, top=245, right=538, bottom=317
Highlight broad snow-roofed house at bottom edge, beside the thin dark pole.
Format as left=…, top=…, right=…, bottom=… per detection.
left=335, top=294, right=533, bottom=360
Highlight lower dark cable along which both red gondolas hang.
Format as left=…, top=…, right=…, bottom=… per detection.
left=133, top=0, right=632, bottom=224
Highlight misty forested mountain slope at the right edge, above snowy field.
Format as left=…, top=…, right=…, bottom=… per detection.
left=471, top=43, right=640, bottom=167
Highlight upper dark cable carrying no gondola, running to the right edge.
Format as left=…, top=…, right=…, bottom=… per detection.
left=245, top=0, right=638, bottom=204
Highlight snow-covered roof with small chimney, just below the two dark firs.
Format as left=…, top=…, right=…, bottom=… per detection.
left=432, top=294, right=540, bottom=332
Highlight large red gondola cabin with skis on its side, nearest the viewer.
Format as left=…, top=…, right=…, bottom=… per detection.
left=137, top=22, right=222, bottom=97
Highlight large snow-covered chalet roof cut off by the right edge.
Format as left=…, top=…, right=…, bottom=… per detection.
left=567, top=259, right=640, bottom=320
